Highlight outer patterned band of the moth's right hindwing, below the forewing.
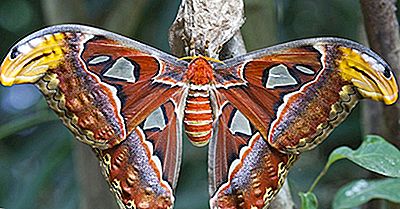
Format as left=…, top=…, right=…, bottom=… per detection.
left=210, top=132, right=297, bottom=208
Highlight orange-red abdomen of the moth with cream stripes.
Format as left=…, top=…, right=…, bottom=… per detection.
left=183, top=90, right=213, bottom=146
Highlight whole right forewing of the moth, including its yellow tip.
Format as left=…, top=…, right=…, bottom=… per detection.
left=214, top=38, right=398, bottom=153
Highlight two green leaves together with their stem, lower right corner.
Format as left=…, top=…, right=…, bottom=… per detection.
left=300, top=135, right=400, bottom=209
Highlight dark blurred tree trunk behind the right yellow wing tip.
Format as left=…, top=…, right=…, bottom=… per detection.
left=360, top=0, right=400, bottom=209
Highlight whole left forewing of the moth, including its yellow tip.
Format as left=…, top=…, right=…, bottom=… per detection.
left=1, top=25, right=187, bottom=149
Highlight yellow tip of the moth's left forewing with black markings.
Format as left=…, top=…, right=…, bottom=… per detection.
left=0, top=33, right=65, bottom=86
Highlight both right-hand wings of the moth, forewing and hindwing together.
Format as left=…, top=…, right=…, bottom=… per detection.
left=210, top=38, right=397, bottom=208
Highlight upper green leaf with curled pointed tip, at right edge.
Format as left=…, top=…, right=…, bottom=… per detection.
left=327, top=135, right=400, bottom=177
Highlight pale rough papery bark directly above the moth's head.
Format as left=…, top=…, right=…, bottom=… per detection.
left=169, top=0, right=244, bottom=58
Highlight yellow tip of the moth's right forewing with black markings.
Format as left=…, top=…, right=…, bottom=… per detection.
left=337, top=46, right=398, bottom=105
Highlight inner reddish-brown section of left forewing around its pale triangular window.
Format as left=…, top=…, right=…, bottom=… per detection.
left=82, top=37, right=185, bottom=148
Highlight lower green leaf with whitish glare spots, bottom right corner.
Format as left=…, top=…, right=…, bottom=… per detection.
left=332, top=178, right=400, bottom=209
